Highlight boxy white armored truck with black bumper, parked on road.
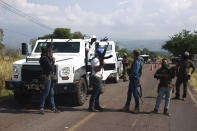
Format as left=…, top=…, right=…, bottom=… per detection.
left=6, top=39, right=122, bottom=105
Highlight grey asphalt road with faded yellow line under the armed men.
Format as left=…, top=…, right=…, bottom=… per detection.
left=0, top=66, right=197, bottom=131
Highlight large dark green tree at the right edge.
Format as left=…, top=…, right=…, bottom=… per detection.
left=162, top=30, right=197, bottom=56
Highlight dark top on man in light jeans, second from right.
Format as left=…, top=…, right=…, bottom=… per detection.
left=154, top=67, right=175, bottom=87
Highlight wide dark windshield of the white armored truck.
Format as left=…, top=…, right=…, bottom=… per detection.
left=35, top=42, right=80, bottom=53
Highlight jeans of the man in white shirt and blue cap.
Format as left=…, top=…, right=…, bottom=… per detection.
left=89, top=76, right=103, bottom=108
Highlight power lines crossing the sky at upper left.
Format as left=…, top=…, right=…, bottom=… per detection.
left=0, top=0, right=53, bottom=30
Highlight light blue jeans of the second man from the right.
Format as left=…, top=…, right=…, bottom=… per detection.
left=155, top=87, right=173, bottom=110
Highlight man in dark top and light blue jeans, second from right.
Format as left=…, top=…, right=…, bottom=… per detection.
left=153, top=58, right=175, bottom=115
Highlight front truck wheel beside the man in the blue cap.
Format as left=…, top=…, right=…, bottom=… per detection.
left=75, top=78, right=87, bottom=106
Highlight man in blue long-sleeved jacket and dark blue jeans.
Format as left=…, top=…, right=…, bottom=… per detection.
left=123, top=50, right=142, bottom=113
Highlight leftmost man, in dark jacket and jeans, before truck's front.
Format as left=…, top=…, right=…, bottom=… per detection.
left=39, top=47, right=59, bottom=114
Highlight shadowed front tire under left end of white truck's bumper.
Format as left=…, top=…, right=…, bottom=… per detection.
left=14, top=88, right=32, bottom=104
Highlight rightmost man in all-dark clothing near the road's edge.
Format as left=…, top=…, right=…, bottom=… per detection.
left=173, top=51, right=195, bottom=100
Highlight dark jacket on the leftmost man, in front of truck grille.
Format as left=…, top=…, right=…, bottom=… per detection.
left=39, top=54, right=54, bottom=75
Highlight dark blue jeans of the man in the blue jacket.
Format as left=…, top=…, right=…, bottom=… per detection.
left=126, top=80, right=140, bottom=108
